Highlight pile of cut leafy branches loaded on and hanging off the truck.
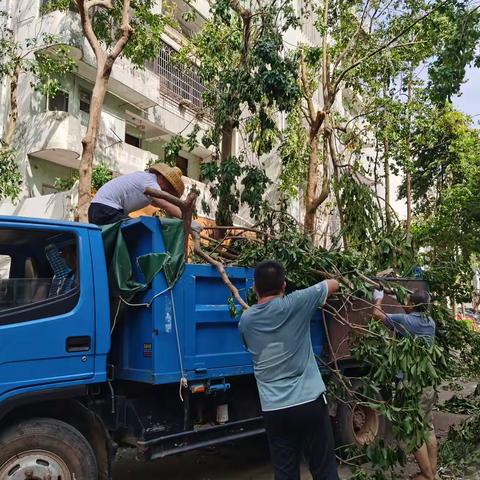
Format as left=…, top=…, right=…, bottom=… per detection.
left=146, top=191, right=480, bottom=479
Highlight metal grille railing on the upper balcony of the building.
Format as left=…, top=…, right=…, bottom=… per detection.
left=146, top=43, right=205, bottom=109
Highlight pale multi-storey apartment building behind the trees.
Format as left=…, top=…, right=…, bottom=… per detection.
left=0, top=0, right=404, bottom=232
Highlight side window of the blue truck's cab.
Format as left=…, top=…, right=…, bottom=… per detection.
left=0, top=229, right=79, bottom=323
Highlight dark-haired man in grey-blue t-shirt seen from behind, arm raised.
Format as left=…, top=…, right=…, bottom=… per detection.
left=239, top=261, right=339, bottom=480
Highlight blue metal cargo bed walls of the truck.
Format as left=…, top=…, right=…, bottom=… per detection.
left=112, top=217, right=325, bottom=384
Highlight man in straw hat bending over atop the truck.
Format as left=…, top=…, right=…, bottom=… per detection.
left=88, top=163, right=201, bottom=231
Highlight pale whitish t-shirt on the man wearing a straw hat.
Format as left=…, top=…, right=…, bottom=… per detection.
left=92, top=172, right=161, bottom=215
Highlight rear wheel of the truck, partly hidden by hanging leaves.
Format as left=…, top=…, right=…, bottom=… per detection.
left=333, top=380, right=386, bottom=447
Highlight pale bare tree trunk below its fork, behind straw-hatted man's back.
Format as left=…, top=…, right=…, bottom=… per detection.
left=78, top=60, right=109, bottom=222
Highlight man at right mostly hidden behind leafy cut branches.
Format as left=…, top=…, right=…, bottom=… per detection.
left=373, top=290, right=437, bottom=480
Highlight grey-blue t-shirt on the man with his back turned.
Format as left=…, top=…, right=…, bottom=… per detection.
left=238, top=282, right=328, bottom=412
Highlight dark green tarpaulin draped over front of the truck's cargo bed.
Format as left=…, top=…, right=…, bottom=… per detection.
left=102, top=218, right=185, bottom=301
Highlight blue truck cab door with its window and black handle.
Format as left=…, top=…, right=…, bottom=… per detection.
left=0, top=221, right=95, bottom=396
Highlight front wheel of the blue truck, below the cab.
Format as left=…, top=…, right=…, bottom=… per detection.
left=0, top=418, right=98, bottom=480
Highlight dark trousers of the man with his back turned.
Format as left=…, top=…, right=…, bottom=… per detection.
left=263, top=395, right=338, bottom=480
